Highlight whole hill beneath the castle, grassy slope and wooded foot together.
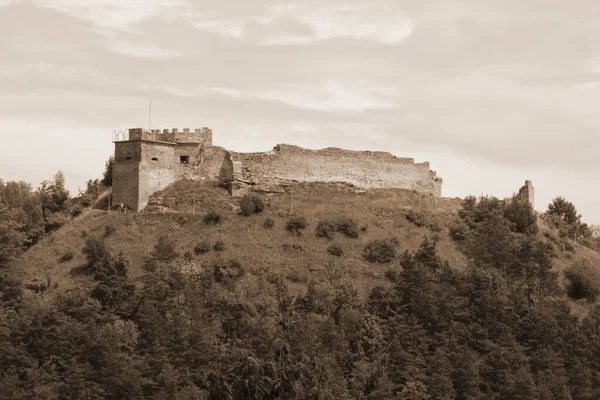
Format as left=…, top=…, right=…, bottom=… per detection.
left=7, top=182, right=600, bottom=400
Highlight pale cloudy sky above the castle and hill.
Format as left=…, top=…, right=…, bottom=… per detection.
left=0, top=0, right=600, bottom=224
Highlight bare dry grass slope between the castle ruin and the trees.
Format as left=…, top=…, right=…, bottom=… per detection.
left=12, top=181, right=600, bottom=304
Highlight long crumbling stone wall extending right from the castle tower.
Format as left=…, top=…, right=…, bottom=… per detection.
left=227, top=145, right=442, bottom=196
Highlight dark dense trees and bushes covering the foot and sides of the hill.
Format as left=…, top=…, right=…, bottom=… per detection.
left=0, top=164, right=600, bottom=400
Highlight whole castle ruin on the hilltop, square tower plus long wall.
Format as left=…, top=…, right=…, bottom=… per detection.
left=113, top=128, right=442, bottom=211
